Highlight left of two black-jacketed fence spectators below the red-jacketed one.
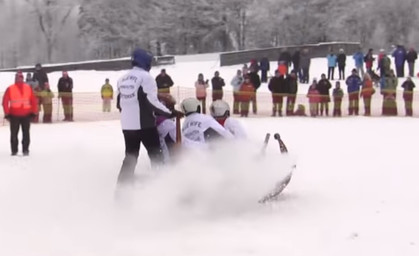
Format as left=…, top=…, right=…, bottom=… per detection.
left=268, top=70, right=288, bottom=116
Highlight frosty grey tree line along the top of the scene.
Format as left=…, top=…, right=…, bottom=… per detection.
left=0, top=0, right=419, bottom=67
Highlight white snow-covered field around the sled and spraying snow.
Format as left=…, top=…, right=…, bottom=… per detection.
left=0, top=53, right=419, bottom=256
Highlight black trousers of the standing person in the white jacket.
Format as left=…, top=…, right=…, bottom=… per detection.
left=118, top=127, right=163, bottom=183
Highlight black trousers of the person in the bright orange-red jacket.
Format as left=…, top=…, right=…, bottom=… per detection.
left=10, top=116, right=31, bottom=154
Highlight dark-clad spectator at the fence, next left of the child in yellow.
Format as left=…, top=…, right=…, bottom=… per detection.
left=58, top=71, right=73, bottom=122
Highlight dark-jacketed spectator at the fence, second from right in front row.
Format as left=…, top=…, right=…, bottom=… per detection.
left=382, top=69, right=398, bottom=116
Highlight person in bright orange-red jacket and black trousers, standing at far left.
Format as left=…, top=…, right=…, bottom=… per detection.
left=2, top=72, right=38, bottom=156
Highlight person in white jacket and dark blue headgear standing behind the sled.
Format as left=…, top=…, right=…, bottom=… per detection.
left=117, top=49, right=180, bottom=184
